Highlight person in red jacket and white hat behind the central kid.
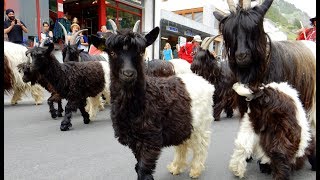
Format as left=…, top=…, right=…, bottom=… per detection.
left=178, top=35, right=202, bottom=64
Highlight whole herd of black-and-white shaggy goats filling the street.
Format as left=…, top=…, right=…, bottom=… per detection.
left=4, top=0, right=316, bottom=180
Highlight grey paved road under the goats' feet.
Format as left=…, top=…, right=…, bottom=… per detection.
left=4, top=93, right=316, bottom=180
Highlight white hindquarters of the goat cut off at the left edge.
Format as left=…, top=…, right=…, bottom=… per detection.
left=4, top=41, right=44, bottom=104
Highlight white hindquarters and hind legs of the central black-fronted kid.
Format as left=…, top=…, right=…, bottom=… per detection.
left=168, top=73, right=215, bottom=178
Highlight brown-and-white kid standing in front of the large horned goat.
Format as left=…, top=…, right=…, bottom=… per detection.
left=229, top=82, right=316, bottom=180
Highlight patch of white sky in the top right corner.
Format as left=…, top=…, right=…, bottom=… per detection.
left=285, top=0, right=316, bottom=18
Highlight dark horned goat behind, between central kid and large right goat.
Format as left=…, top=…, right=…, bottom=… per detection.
left=190, top=37, right=238, bottom=121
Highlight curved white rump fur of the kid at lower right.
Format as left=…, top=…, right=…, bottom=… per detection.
left=266, top=82, right=311, bottom=157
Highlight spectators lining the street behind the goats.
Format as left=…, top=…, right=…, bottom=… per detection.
left=4, top=9, right=316, bottom=63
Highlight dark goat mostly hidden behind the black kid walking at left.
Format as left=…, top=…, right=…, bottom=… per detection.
left=17, top=62, right=63, bottom=118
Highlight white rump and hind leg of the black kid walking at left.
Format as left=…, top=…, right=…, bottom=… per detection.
left=85, top=61, right=110, bottom=120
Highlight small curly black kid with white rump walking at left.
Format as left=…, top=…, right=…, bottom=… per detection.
left=26, top=44, right=109, bottom=131
